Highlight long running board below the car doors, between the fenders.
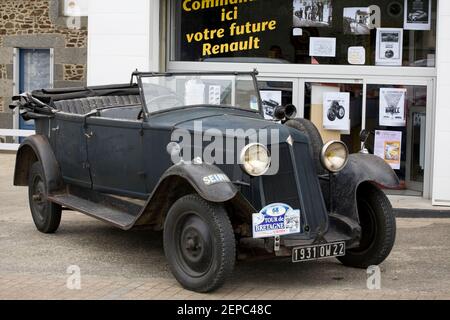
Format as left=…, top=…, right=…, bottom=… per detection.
left=48, top=189, right=143, bottom=230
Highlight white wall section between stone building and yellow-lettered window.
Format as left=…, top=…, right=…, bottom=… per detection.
left=88, top=0, right=159, bottom=85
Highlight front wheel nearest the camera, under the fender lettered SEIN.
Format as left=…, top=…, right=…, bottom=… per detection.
left=164, top=194, right=236, bottom=293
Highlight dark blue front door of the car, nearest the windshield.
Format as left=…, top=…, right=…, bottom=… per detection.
left=86, top=117, right=150, bottom=198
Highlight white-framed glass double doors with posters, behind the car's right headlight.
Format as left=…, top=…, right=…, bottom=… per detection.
left=299, top=77, right=433, bottom=197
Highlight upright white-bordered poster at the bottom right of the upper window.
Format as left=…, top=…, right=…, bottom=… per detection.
left=375, top=28, right=403, bottom=66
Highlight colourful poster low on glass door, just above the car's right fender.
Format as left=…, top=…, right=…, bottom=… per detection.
left=374, top=130, right=402, bottom=170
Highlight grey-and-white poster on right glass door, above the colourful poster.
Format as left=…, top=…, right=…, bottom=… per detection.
left=379, top=88, right=407, bottom=127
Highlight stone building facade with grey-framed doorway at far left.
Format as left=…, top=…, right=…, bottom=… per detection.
left=0, top=0, right=87, bottom=129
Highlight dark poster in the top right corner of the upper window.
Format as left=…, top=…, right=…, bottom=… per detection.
left=404, top=0, right=431, bottom=30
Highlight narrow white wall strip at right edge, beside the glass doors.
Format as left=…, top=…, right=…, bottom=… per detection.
left=433, top=0, right=450, bottom=206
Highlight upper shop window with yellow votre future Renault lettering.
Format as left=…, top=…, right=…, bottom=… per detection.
left=171, top=0, right=437, bottom=67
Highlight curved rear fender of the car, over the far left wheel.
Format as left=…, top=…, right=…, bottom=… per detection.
left=14, top=135, right=63, bottom=193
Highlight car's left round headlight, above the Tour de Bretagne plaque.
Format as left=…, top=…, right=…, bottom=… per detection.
left=240, top=143, right=270, bottom=177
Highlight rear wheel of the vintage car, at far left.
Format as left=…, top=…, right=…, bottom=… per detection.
left=28, top=162, right=62, bottom=233
